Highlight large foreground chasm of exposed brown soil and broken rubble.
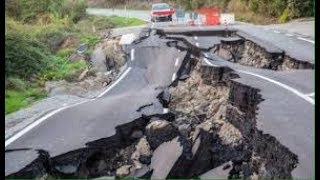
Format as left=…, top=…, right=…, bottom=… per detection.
left=6, top=52, right=298, bottom=179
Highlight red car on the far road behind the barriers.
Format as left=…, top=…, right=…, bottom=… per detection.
left=150, top=3, right=174, bottom=22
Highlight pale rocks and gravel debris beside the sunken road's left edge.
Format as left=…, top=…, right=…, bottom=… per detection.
left=45, top=37, right=126, bottom=98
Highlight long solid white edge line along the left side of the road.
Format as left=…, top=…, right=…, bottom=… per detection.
left=5, top=67, right=131, bottom=147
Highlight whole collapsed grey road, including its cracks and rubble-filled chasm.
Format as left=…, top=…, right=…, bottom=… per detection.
left=5, top=25, right=314, bottom=179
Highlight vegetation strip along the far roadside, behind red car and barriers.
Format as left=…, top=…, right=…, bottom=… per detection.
left=89, top=0, right=314, bottom=24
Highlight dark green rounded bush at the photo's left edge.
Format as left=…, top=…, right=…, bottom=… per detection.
left=5, top=32, right=49, bottom=79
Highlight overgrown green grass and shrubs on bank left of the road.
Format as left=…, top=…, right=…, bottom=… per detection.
left=5, top=15, right=145, bottom=114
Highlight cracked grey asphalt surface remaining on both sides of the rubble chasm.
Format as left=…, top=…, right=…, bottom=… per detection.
left=5, top=10, right=314, bottom=177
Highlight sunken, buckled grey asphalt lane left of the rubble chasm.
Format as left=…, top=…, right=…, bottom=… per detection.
left=5, top=32, right=186, bottom=175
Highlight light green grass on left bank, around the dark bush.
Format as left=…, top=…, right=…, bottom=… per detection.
left=5, top=15, right=145, bottom=114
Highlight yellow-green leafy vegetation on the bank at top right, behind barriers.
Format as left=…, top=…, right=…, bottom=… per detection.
left=176, top=0, right=314, bottom=24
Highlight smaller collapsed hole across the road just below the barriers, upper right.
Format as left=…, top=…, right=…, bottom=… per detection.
left=157, top=27, right=314, bottom=71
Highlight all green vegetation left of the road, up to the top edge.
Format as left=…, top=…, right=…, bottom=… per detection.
left=5, top=0, right=144, bottom=114
